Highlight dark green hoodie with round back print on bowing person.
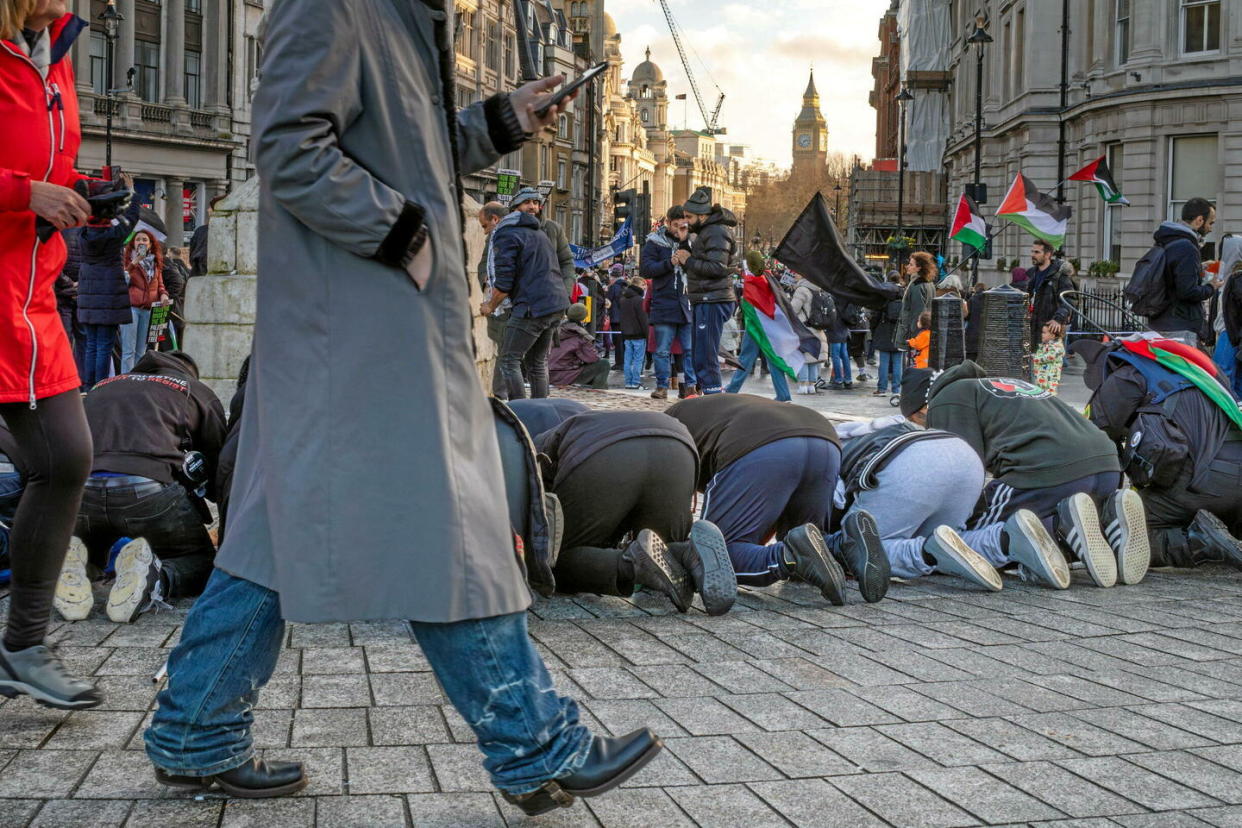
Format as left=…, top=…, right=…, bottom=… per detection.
left=928, top=360, right=1122, bottom=489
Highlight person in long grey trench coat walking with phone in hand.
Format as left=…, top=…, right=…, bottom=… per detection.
left=145, top=0, right=661, bottom=813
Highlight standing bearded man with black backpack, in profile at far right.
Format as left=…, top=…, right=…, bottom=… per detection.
left=1148, top=197, right=1227, bottom=339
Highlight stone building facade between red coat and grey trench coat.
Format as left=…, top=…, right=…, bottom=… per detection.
left=68, top=0, right=263, bottom=245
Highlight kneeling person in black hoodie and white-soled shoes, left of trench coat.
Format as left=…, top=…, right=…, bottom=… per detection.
left=56, top=351, right=225, bottom=623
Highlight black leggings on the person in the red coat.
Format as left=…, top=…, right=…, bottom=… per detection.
left=0, top=390, right=91, bottom=650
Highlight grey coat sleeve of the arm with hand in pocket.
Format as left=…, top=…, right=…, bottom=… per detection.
left=255, top=0, right=422, bottom=266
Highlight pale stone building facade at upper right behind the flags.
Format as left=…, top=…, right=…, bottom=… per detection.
left=943, top=0, right=1242, bottom=277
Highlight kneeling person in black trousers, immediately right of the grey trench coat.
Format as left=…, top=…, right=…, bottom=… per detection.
left=535, top=411, right=738, bottom=616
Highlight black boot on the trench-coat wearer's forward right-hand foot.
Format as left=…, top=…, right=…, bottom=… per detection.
left=502, top=727, right=664, bottom=817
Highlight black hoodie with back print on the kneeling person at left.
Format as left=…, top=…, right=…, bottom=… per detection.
left=86, top=351, right=225, bottom=500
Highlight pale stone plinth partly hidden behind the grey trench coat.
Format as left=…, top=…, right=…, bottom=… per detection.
left=183, top=176, right=496, bottom=407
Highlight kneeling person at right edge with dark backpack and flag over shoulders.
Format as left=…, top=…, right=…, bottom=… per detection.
left=1073, top=340, right=1242, bottom=567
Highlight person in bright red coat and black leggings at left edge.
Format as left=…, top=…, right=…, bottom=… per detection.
left=0, top=0, right=125, bottom=710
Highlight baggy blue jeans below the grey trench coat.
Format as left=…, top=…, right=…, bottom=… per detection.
left=144, top=570, right=591, bottom=794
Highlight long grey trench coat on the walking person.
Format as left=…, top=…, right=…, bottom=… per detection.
left=216, top=0, right=530, bottom=622
